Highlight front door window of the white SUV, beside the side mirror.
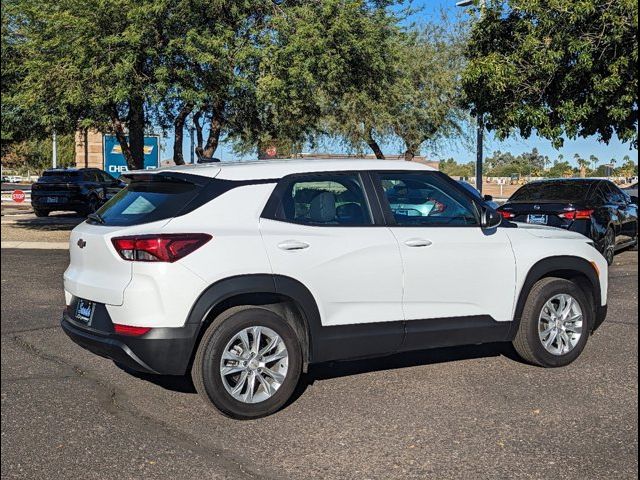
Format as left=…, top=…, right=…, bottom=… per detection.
left=378, top=172, right=478, bottom=226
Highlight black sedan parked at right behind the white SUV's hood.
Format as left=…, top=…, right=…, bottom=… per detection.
left=499, top=178, right=638, bottom=264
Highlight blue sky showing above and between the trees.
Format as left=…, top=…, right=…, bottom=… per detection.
left=162, top=0, right=638, bottom=168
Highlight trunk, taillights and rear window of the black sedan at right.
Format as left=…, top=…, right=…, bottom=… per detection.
left=499, top=179, right=597, bottom=228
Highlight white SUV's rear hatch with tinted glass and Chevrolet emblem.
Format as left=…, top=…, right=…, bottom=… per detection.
left=64, top=173, right=211, bottom=305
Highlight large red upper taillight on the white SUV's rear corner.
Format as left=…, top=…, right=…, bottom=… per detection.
left=111, top=233, right=212, bottom=263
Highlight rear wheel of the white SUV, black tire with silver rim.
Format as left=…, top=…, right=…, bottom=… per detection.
left=191, top=306, right=302, bottom=420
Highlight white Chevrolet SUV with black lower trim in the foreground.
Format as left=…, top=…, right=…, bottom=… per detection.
left=62, top=160, right=607, bottom=418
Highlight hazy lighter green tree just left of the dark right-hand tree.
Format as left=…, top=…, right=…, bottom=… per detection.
left=323, top=17, right=468, bottom=160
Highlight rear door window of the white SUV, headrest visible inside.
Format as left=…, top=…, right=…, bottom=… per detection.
left=275, top=174, right=373, bottom=226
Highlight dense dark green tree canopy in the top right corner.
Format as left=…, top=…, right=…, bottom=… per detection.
left=463, top=0, right=638, bottom=147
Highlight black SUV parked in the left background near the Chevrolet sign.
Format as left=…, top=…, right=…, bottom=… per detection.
left=31, top=168, right=125, bottom=217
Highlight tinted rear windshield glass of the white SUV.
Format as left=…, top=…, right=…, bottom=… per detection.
left=97, top=176, right=202, bottom=226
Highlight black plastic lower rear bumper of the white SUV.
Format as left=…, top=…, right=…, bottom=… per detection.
left=61, top=305, right=199, bottom=375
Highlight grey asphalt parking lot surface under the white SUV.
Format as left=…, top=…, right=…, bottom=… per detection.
left=1, top=248, right=638, bottom=479
